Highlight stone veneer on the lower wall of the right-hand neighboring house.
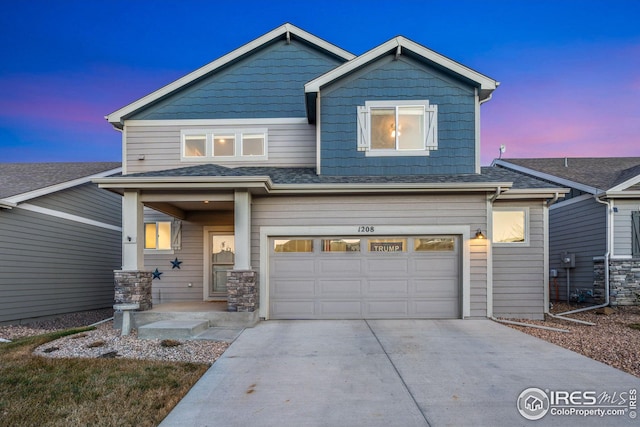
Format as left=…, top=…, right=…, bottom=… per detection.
left=593, top=258, right=640, bottom=306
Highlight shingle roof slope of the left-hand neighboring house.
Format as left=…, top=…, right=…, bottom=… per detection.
left=0, top=162, right=121, bottom=199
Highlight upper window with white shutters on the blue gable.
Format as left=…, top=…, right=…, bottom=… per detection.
left=358, top=100, right=438, bottom=156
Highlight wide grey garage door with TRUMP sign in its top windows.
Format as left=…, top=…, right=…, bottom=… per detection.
left=269, top=236, right=461, bottom=319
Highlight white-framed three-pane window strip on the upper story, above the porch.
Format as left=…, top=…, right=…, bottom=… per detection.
left=180, top=128, right=267, bottom=162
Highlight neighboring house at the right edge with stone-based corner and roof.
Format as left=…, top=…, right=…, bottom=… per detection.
left=494, top=157, right=640, bottom=305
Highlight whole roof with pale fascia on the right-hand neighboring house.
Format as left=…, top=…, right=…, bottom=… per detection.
left=494, top=157, right=640, bottom=194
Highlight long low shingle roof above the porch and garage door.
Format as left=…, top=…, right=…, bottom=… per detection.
left=127, top=164, right=560, bottom=189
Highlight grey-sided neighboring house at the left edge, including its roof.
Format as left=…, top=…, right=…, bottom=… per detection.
left=0, top=162, right=122, bottom=324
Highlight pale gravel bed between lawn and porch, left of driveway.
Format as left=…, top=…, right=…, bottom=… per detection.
left=0, top=310, right=229, bottom=365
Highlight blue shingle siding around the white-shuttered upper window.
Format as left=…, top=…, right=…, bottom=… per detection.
left=321, top=56, right=476, bottom=175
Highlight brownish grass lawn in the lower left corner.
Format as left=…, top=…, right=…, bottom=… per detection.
left=0, top=328, right=209, bottom=427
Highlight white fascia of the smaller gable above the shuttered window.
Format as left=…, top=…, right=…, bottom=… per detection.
left=304, top=36, right=500, bottom=99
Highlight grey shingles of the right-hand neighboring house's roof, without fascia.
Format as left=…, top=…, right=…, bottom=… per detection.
left=502, top=157, right=640, bottom=190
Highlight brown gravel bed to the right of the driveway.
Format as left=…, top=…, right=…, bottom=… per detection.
left=507, top=304, right=640, bottom=377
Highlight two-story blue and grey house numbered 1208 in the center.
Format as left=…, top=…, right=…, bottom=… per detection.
left=95, top=24, right=566, bottom=319
